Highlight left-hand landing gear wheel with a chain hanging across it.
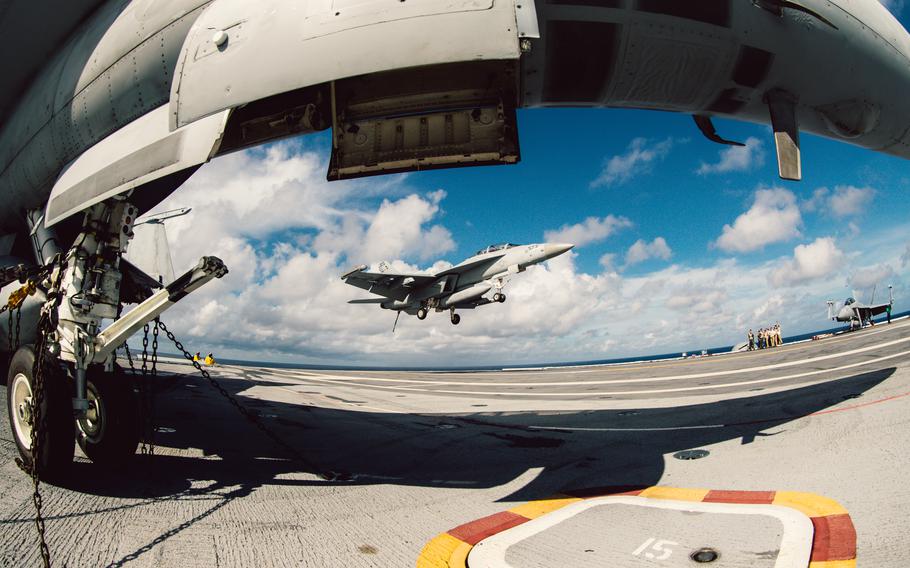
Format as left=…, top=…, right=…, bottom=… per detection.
left=6, top=345, right=76, bottom=479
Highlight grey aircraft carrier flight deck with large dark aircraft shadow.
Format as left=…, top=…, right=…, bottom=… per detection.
left=0, top=322, right=910, bottom=568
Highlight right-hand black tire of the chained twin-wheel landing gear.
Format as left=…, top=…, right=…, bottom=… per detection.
left=76, top=368, right=140, bottom=465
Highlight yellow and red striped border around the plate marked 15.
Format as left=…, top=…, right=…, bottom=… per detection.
left=417, top=487, right=856, bottom=568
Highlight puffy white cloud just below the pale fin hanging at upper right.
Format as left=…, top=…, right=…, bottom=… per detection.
left=714, top=188, right=802, bottom=252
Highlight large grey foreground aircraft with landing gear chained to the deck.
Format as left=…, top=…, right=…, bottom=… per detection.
left=0, top=0, right=910, bottom=472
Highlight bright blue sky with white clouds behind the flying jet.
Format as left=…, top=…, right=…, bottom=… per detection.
left=139, top=3, right=910, bottom=366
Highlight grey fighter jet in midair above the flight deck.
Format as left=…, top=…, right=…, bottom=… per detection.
left=341, top=243, right=575, bottom=331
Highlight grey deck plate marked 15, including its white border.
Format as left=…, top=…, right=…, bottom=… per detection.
left=468, top=496, right=813, bottom=568
